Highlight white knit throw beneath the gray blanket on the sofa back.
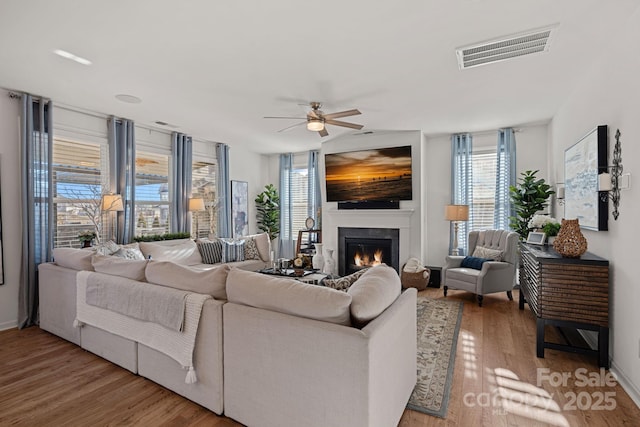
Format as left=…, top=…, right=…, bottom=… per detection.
left=74, top=271, right=212, bottom=384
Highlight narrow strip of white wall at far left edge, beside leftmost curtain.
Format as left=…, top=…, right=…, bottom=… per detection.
left=0, top=89, right=22, bottom=330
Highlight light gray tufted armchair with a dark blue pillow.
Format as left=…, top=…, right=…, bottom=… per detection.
left=442, top=230, right=518, bottom=307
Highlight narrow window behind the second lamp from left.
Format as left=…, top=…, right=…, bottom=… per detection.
left=191, top=161, right=218, bottom=238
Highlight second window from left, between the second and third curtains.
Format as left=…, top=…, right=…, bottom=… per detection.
left=134, top=149, right=170, bottom=236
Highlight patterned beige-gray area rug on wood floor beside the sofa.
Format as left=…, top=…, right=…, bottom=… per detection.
left=407, top=297, right=463, bottom=418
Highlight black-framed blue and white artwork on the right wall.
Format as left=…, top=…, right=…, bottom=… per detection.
left=564, top=125, right=609, bottom=231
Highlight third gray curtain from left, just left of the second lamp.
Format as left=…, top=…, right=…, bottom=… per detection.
left=169, top=132, right=193, bottom=233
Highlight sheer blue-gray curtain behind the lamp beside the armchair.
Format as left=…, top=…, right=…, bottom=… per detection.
left=449, top=133, right=473, bottom=255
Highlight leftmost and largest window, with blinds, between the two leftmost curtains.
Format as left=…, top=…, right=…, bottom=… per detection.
left=52, top=138, right=108, bottom=247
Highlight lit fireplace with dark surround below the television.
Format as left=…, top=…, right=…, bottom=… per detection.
left=338, top=227, right=400, bottom=276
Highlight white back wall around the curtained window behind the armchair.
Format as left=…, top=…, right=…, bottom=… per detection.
left=424, top=124, right=554, bottom=266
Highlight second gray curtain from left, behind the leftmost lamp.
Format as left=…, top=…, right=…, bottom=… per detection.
left=107, top=116, right=136, bottom=244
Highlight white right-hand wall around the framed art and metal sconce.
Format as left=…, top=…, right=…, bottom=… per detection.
left=551, top=11, right=640, bottom=405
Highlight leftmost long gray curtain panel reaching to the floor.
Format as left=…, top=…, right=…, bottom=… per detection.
left=18, top=94, right=53, bottom=328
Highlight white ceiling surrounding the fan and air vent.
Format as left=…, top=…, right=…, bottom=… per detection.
left=0, top=0, right=638, bottom=153
